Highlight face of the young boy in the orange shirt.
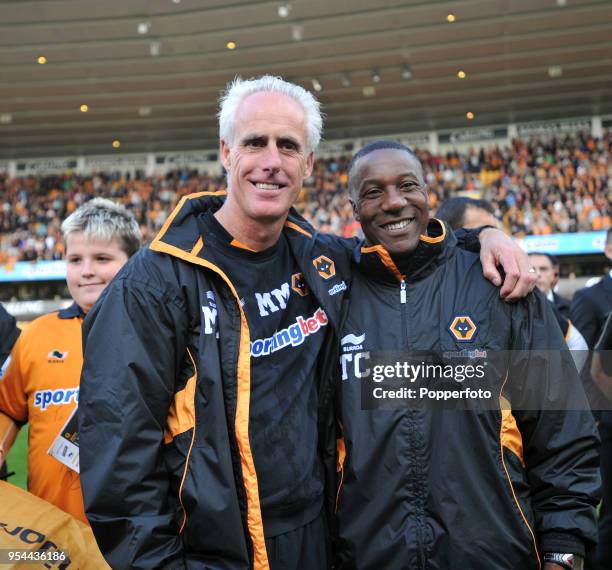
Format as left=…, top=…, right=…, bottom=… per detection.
left=66, top=232, right=128, bottom=313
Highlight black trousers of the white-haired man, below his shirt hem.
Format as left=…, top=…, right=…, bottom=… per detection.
left=266, top=512, right=331, bottom=570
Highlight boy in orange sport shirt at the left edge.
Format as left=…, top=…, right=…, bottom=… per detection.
left=0, top=198, right=140, bottom=524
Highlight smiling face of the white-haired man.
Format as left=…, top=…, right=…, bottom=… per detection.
left=221, top=92, right=313, bottom=223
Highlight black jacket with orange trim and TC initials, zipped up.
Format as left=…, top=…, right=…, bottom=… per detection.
left=330, top=220, right=600, bottom=570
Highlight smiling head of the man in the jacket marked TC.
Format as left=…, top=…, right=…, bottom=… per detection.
left=350, top=149, right=429, bottom=255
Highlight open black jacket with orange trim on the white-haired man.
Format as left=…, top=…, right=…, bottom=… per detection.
left=79, top=193, right=356, bottom=570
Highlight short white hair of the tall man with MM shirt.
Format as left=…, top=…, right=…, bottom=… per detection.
left=217, top=75, right=323, bottom=153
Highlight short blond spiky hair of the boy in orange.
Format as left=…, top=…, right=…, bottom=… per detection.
left=62, top=198, right=142, bottom=257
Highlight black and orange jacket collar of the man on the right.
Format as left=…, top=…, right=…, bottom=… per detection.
left=358, top=218, right=457, bottom=283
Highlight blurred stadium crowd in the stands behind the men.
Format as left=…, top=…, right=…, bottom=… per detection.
left=0, top=132, right=612, bottom=263
